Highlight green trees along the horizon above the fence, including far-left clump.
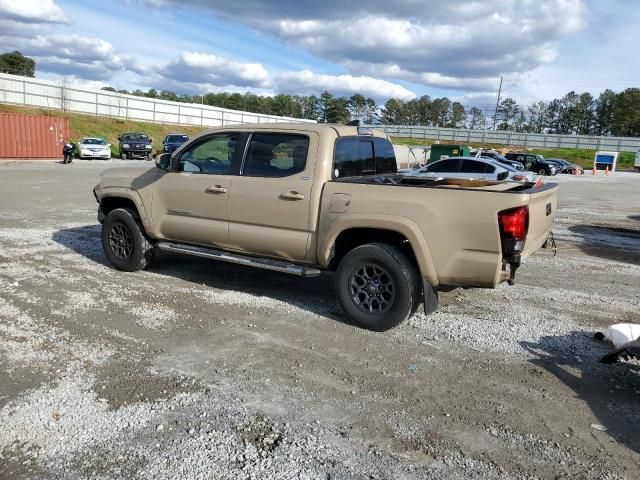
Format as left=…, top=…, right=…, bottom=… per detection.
left=0, top=51, right=640, bottom=137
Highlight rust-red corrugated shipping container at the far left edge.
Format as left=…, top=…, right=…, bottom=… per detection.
left=0, top=113, right=69, bottom=159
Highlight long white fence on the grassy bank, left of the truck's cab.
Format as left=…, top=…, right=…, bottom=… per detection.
left=0, top=73, right=315, bottom=127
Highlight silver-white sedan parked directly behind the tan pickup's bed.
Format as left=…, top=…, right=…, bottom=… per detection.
left=399, top=157, right=536, bottom=182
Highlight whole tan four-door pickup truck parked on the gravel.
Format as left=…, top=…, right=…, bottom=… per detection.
left=94, top=123, right=557, bottom=330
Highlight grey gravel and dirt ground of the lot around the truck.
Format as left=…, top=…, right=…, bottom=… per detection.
left=0, top=160, right=640, bottom=480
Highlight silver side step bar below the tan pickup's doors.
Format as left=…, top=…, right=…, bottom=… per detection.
left=156, top=242, right=321, bottom=277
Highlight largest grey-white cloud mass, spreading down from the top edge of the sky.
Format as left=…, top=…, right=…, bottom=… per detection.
left=147, top=0, right=586, bottom=90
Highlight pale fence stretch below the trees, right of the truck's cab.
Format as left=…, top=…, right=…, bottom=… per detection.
left=375, top=125, right=640, bottom=152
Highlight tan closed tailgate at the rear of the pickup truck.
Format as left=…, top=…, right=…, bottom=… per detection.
left=522, top=184, right=558, bottom=257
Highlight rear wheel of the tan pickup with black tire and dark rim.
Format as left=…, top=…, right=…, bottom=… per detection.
left=336, top=243, right=421, bottom=332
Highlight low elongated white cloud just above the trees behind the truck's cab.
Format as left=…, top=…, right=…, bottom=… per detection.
left=274, top=70, right=416, bottom=100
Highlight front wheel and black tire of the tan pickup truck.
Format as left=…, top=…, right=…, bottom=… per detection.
left=102, top=208, right=154, bottom=272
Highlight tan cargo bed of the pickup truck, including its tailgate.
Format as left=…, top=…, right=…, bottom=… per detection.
left=320, top=175, right=558, bottom=287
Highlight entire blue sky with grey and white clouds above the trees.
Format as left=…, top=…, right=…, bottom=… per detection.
left=0, top=0, right=640, bottom=110
